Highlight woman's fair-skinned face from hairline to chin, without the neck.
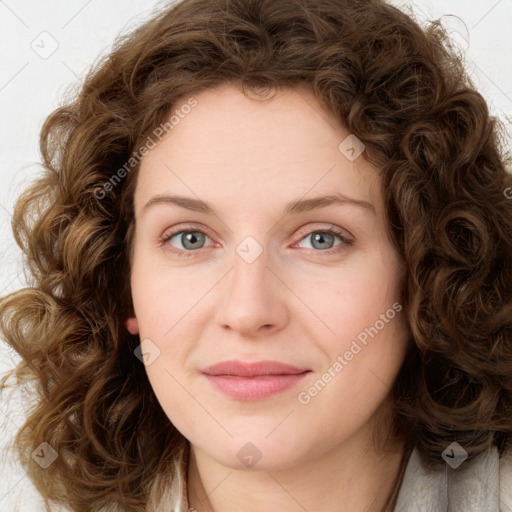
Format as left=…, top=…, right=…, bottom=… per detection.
left=127, top=85, right=409, bottom=469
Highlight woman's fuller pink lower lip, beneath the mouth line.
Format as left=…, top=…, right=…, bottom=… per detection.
left=205, top=372, right=309, bottom=400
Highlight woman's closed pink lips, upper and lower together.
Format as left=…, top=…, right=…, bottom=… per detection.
left=201, top=360, right=311, bottom=401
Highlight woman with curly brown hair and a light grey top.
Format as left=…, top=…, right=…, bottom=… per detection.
left=1, top=0, right=512, bottom=512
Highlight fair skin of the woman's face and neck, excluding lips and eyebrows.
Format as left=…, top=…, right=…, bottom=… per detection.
left=127, top=84, right=409, bottom=512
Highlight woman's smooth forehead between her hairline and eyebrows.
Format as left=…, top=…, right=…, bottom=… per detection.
left=135, top=84, right=379, bottom=214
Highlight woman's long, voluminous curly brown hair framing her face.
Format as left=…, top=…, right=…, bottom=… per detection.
left=0, top=0, right=512, bottom=511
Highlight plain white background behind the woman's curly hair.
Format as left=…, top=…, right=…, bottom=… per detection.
left=0, top=0, right=512, bottom=512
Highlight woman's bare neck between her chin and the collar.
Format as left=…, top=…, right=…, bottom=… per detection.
left=187, top=422, right=408, bottom=512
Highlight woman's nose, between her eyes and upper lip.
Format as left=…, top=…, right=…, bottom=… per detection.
left=216, top=242, right=288, bottom=337
